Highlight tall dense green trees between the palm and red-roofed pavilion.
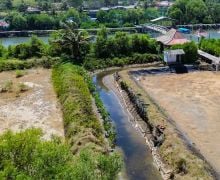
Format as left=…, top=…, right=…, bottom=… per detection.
left=94, top=28, right=157, bottom=58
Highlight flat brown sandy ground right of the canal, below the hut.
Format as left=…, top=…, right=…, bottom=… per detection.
left=138, top=72, right=220, bottom=174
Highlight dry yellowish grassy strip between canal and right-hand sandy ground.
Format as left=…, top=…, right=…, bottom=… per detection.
left=119, top=71, right=213, bottom=180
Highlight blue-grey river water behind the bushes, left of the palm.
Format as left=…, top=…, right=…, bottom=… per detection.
left=0, top=36, right=49, bottom=47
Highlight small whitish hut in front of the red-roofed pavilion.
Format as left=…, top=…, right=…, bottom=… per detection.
left=164, top=49, right=185, bottom=65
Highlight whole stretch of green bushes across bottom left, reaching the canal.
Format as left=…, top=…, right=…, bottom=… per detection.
left=0, top=129, right=121, bottom=180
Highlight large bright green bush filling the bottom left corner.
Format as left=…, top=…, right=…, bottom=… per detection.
left=0, top=129, right=74, bottom=179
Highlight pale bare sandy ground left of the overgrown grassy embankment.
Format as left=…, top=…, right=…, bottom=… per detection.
left=0, top=69, right=64, bottom=139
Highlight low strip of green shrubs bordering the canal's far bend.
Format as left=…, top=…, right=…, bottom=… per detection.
left=83, top=53, right=162, bottom=70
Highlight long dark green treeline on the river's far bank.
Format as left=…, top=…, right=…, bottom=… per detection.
left=3, top=8, right=159, bottom=30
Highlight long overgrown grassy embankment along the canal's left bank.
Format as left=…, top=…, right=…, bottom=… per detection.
left=52, top=63, right=121, bottom=179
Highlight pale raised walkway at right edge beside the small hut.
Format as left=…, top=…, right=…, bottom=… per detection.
left=198, top=50, right=220, bottom=71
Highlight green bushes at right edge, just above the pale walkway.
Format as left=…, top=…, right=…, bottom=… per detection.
left=199, top=39, right=220, bottom=57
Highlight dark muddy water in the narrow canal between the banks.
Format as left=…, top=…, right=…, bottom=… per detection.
left=94, top=73, right=161, bottom=180
